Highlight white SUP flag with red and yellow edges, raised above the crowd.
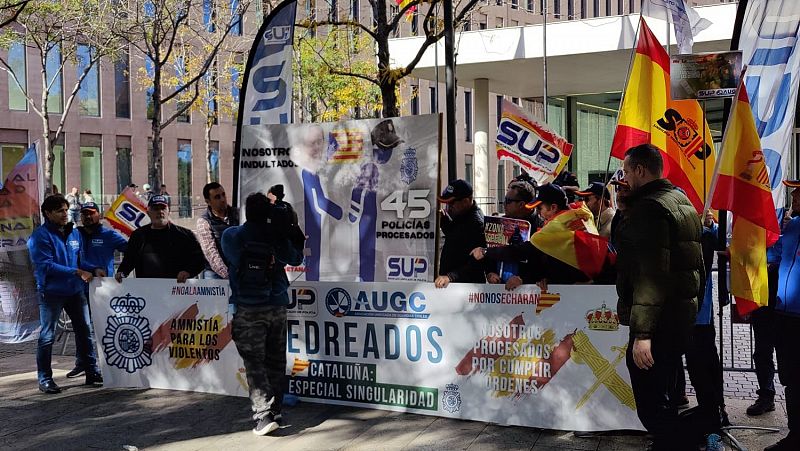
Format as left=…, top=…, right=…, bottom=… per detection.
left=495, top=100, right=572, bottom=186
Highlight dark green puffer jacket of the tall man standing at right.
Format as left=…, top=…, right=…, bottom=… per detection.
left=616, top=179, right=705, bottom=346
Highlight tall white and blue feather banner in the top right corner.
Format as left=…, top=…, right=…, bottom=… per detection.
left=739, top=0, right=800, bottom=214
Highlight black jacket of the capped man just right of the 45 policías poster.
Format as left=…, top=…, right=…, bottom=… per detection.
left=439, top=202, right=486, bottom=283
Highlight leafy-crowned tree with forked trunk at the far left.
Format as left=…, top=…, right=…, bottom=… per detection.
left=0, top=0, right=120, bottom=193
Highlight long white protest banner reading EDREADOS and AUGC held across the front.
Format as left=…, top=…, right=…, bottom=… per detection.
left=91, top=279, right=642, bottom=431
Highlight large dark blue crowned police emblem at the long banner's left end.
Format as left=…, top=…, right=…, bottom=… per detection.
left=103, top=293, right=153, bottom=373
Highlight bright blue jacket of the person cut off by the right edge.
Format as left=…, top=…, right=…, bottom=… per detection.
left=768, top=216, right=800, bottom=316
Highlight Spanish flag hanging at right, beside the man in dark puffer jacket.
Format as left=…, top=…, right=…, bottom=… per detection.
left=711, top=76, right=780, bottom=315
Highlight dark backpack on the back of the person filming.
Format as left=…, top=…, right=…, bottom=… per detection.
left=236, top=241, right=275, bottom=297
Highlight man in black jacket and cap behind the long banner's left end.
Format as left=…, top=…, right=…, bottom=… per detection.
left=114, top=195, right=205, bottom=283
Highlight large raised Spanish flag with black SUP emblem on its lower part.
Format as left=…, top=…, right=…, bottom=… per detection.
left=611, top=18, right=716, bottom=213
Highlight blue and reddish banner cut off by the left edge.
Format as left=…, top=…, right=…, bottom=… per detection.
left=0, top=145, right=40, bottom=343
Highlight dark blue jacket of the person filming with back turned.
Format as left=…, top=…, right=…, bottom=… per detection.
left=221, top=222, right=303, bottom=306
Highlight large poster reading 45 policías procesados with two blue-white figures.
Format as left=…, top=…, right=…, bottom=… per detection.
left=239, top=115, right=440, bottom=282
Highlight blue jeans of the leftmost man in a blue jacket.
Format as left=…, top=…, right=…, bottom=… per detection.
left=36, top=291, right=100, bottom=384
